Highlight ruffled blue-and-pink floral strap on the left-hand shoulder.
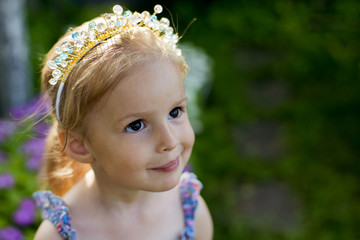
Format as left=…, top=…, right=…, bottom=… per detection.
left=33, top=191, right=76, bottom=240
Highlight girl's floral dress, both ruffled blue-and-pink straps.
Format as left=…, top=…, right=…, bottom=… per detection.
left=33, top=172, right=202, bottom=240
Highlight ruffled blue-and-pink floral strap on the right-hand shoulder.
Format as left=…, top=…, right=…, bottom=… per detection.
left=179, top=172, right=203, bottom=240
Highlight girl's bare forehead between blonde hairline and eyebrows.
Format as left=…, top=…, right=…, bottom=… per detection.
left=93, top=59, right=185, bottom=118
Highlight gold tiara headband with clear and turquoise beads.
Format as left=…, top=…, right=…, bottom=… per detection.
left=47, top=4, right=181, bottom=120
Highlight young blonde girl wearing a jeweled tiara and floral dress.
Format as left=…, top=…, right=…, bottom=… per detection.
left=34, top=5, right=213, bottom=240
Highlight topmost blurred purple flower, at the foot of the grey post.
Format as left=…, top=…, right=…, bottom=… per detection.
left=11, top=96, right=50, bottom=119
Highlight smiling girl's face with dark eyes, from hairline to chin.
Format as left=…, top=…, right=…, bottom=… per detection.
left=85, top=60, right=194, bottom=192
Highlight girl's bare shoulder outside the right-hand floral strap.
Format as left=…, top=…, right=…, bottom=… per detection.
left=195, top=196, right=214, bottom=240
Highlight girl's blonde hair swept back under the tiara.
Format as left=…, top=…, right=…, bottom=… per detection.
left=41, top=16, right=187, bottom=196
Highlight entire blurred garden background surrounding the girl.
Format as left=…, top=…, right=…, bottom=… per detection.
left=0, top=0, right=360, bottom=240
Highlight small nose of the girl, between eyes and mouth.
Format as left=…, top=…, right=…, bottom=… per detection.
left=156, top=122, right=179, bottom=153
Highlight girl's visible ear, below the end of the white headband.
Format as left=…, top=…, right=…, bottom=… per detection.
left=59, top=132, right=93, bottom=163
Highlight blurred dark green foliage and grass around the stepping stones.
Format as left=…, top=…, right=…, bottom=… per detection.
left=3, top=0, right=360, bottom=240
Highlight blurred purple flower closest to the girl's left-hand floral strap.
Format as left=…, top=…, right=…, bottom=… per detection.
left=13, top=198, right=36, bottom=226
